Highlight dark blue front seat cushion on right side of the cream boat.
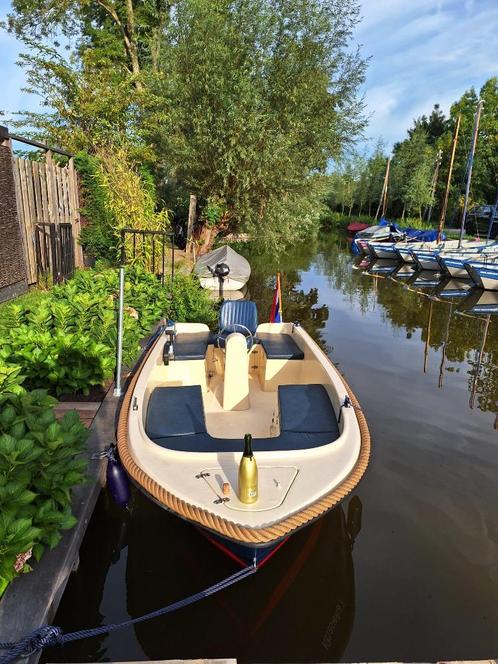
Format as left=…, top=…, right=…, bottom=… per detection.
left=278, top=385, right=339, bottom=435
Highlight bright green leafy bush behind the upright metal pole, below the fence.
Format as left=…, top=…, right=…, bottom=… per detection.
left=0, top=267, right=216, bottom=395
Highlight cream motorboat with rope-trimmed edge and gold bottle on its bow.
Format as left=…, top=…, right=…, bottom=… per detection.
left=118, top=300, right=370, bottom=562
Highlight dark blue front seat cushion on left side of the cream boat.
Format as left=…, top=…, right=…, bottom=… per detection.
left=145, top=385, right=206, bottom=440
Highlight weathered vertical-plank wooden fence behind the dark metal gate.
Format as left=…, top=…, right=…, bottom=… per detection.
left=13, top=151, right=83, bottom=284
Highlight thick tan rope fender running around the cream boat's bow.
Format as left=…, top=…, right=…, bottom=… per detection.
left=117, top=346, right=370, bottom=544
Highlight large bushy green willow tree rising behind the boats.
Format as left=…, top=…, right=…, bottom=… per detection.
left=154, top=0, right=365, bottom=248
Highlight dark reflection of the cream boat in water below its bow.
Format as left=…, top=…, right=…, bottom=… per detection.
left=44, top=492, right=362, bottom=662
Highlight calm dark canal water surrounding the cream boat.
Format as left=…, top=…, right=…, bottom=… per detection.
left=44, top=235, right=498, bottom=662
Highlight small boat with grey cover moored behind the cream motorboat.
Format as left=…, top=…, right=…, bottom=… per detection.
left=194, top=245, right=251, bottom=291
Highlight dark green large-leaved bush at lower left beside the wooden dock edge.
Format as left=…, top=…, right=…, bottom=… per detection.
left=0, top=363, right=88, bottom=596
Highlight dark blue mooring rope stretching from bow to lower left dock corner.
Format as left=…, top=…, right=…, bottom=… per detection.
left=0, top=562, right=258, bottom=664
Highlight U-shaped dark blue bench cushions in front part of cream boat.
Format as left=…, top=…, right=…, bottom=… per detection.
left=145, top=385, right=340, bottom=452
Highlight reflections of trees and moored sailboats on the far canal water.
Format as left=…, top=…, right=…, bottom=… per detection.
left=242, top=235, right=498, bottom=420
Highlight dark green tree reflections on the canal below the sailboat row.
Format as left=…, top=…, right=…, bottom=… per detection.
left=238, top=233, right=498, bottom=420
